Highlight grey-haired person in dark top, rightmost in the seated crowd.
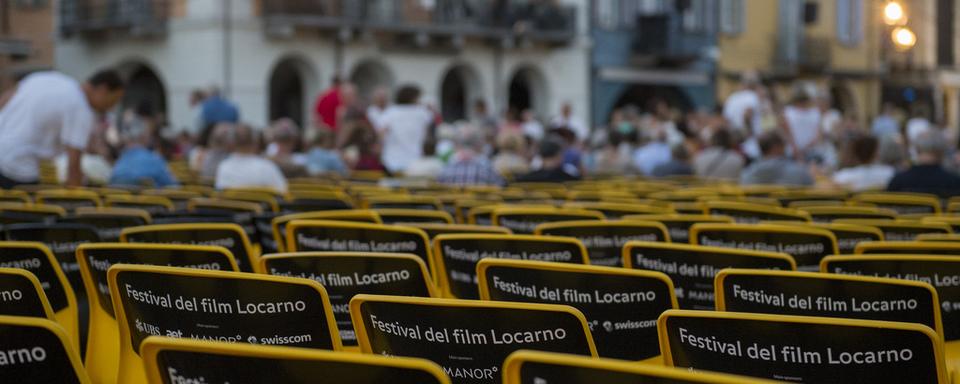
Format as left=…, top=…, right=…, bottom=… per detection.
left=887, top=130, right=960, bottom=198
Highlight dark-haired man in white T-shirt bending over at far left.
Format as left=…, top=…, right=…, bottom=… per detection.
left=0, top=70, right=124, bottom=188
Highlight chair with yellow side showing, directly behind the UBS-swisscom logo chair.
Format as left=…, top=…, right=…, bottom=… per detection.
left=77, top=243, right=237, bottom=383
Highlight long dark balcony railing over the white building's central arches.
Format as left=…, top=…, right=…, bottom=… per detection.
left=261, top=0, right=576, bottom=43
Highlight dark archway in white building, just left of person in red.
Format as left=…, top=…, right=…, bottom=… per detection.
left=269, top=57, right=316, bottom=129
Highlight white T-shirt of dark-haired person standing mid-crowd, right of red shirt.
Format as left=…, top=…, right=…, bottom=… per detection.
left=380, top=104, right=433, bottom=172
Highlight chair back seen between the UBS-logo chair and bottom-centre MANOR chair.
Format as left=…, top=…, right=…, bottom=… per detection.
left=261, top=252, right=433, bottom=346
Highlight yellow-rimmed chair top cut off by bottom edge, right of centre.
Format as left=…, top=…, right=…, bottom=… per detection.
left=503, top=351, right=774, bottom=384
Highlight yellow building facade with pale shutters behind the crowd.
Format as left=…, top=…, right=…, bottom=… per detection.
left=717, top=0, right=885, bottom=123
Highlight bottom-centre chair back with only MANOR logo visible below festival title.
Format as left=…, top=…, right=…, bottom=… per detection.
left=350, top=295, right=597, bottom=384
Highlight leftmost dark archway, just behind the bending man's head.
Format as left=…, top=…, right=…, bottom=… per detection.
left=120, top=63, right=167, bottom=123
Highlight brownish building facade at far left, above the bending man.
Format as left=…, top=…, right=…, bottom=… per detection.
left=0, top=0, right=54, bottom=90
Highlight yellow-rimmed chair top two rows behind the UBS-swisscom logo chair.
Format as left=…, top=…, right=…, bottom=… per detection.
left=120, top=223, right=259, bottom=272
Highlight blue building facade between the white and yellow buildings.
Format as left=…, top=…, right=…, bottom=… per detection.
left=590, top=0, right=717, bottom=124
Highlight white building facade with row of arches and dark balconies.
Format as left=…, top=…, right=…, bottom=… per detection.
left=56, top=0, right=590, bottom=134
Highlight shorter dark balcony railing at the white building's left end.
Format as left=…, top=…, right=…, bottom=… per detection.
left=60, top=0, right=170, bottom=36
